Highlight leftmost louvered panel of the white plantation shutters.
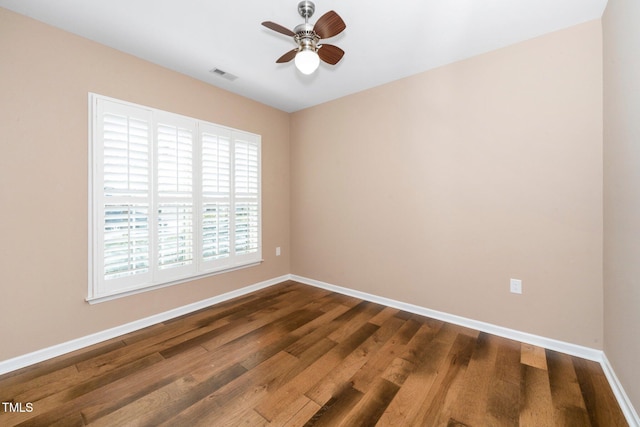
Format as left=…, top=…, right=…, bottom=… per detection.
left=93, top=100, right=152, bottom=293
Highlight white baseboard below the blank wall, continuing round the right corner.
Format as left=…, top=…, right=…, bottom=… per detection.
left=290, top=274, right=640, bottom=427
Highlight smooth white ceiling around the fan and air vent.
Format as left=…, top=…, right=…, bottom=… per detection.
left=0, top=0, right=607, bottom=112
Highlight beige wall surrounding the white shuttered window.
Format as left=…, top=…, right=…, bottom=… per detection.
left=0, top=8, right=290, bottom=360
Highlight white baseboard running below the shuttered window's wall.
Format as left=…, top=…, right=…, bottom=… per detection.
left=0, top=275, right=290, bottom=375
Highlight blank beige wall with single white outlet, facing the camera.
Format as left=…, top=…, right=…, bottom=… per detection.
left=291, top=20, right=603, bottom=348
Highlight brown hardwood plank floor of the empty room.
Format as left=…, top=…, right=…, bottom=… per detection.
left=0, top=282, right=627, bottom=427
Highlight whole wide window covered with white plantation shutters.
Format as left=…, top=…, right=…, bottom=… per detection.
left=88, top=94, right=262, bottom=301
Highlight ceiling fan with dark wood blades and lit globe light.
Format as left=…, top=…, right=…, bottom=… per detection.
left=262, top=0, right=347, bottom=74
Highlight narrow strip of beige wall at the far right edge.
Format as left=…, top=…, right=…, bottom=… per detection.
left=602, top=0, right=640, bottom=410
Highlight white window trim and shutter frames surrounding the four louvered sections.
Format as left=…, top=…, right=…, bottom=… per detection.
left=86, top=93, right=262, bottom=304
